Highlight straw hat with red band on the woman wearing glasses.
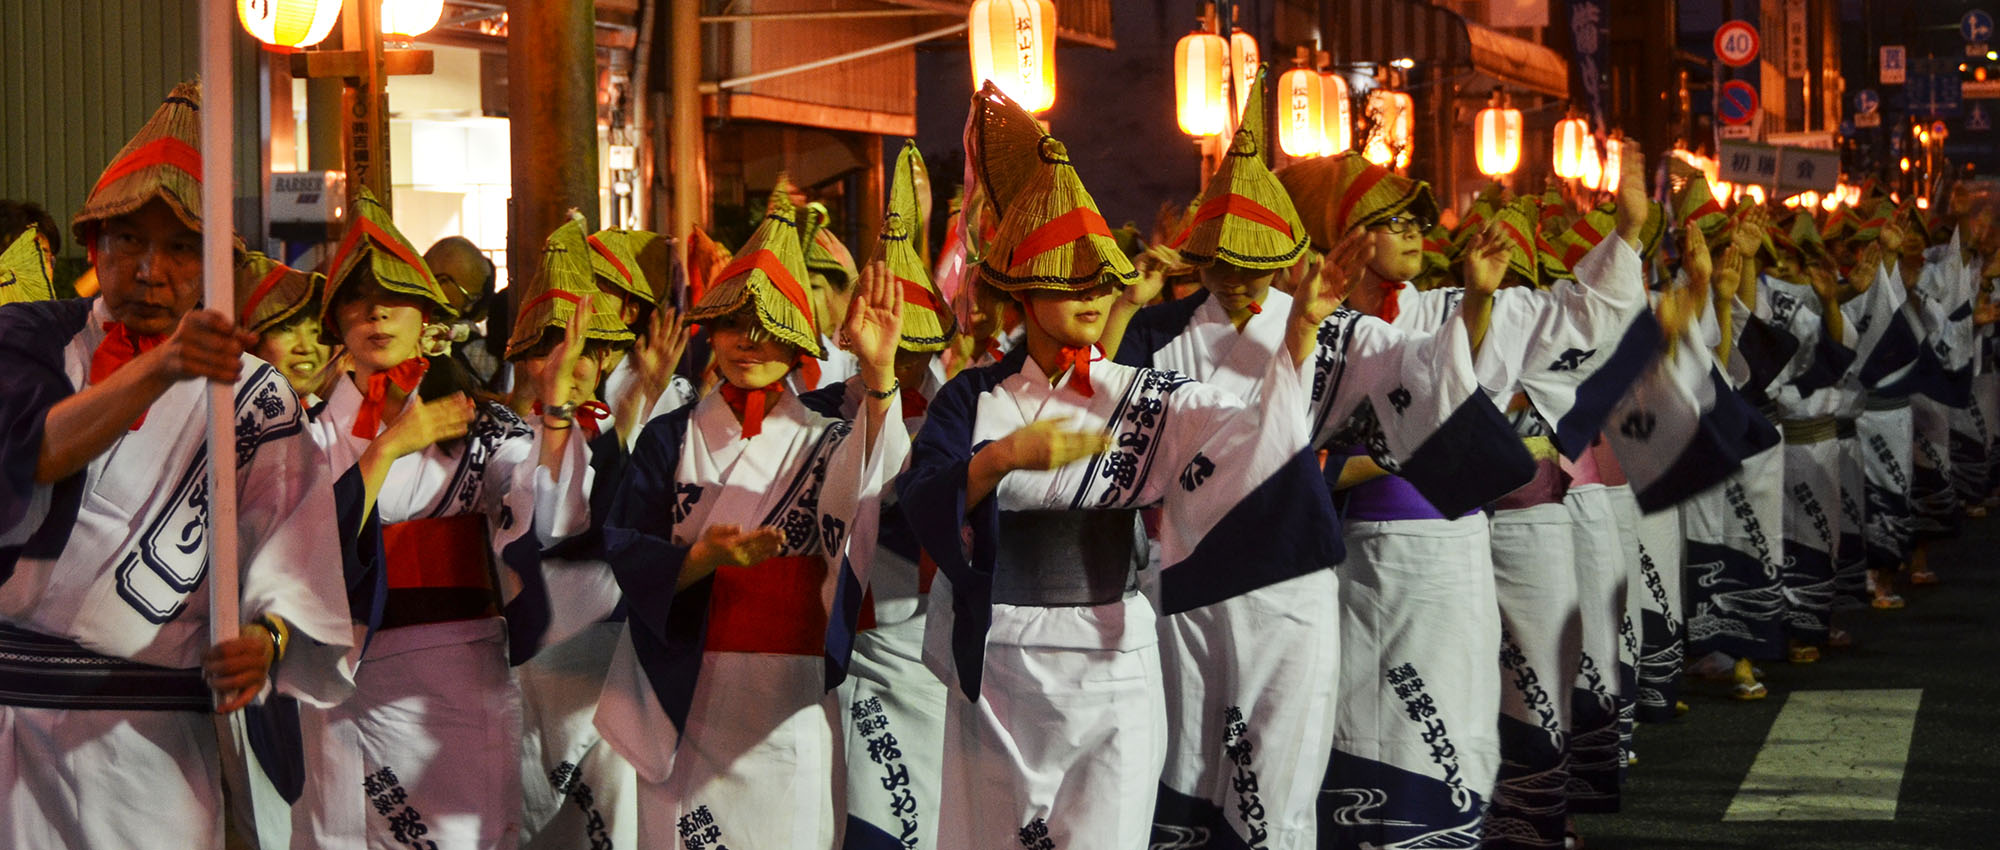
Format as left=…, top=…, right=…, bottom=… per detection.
left=1278, top=152, right=1438, bottom=252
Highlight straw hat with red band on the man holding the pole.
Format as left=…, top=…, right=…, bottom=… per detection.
left=70, top=80, right=202, bottom=244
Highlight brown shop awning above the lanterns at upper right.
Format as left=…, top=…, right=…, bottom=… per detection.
left=1322, top=0, right=1570, bottom=98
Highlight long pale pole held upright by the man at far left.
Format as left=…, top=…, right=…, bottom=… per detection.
left=196, top=0, right=242, bottom=644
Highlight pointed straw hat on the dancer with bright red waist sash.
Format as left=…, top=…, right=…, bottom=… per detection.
left=688, top=176, right=826, bottom=358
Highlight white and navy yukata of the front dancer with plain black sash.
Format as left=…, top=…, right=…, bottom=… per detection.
left=898, top=338, right=1338, bottom=850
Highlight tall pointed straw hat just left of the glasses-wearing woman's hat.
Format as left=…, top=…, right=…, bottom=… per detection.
left=1174, top=72, right=1308, bottom=268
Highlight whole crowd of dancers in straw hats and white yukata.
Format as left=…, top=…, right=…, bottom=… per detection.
left=0, top=73, right=2000, bottom=850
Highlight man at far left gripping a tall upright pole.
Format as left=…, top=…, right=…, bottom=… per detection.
left=0, top=84, right=352, bottom=848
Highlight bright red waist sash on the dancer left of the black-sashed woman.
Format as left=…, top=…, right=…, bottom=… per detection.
left=704, top=556, right=826, bottom=656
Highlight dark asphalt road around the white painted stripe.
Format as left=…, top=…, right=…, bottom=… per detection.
left=1578, top=516, right=2000, bottom=850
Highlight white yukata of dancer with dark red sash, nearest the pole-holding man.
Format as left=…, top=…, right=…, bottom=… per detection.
left=294, top=378, right=590, bottom=850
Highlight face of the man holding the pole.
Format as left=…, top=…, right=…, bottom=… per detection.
left=96, top=200, right=202, bottom=334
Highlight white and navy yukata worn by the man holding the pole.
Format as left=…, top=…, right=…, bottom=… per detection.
left=0, top=300, right=352, bottom=850
